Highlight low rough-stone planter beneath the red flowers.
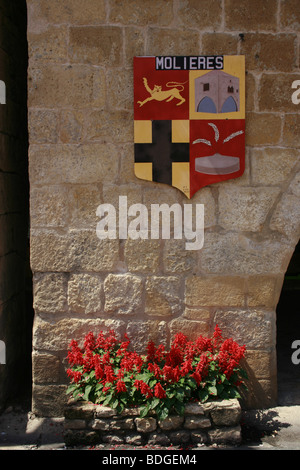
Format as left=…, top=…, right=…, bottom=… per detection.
left=64, top=399, right=241, bottom=447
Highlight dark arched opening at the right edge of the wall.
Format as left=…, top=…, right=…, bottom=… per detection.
left=276, top=242, right=300, bottom=405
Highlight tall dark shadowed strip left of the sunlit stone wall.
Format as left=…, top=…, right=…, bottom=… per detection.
left=0, top=0, right=32, bottom=409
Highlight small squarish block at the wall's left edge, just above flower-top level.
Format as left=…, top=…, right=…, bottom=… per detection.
left=33, top=273, right=67, bottom=313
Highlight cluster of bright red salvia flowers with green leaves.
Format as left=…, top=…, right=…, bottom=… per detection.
left=67, top=325, right=246, bottom=418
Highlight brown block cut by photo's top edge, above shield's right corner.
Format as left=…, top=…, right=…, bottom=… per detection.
left=225, top=0, right=277, bottom=31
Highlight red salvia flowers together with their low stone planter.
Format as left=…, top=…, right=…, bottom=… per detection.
left=65, top=325, right=247, bottom=445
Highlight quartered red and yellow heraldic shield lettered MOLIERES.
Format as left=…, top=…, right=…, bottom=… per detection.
left=134, top=55, right=245, bottom=199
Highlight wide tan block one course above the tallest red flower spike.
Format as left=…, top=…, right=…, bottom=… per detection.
left=185, top=276, right=245, bottom=307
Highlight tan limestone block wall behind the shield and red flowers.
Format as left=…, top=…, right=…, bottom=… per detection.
left=27, top=0, right=300, bottom=415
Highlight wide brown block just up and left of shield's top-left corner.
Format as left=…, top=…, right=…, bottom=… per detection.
left=69, top=25, right=123, bottom=67
